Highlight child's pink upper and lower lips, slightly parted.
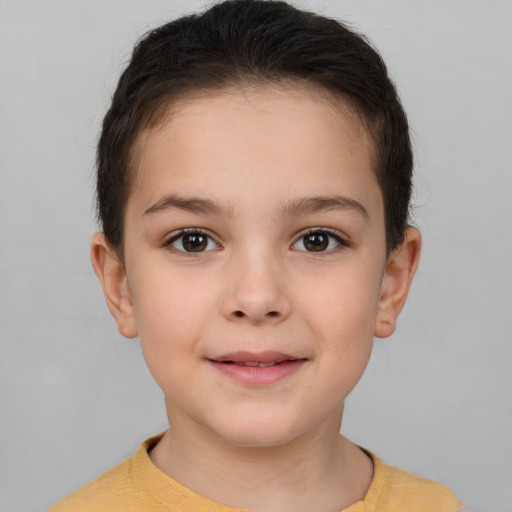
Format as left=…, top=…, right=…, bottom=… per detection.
left=208, top=351, right=307, bottom=387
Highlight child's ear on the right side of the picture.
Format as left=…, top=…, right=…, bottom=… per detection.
left=375, top=227, right=421, bottom=338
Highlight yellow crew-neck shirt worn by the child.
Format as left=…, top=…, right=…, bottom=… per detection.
left=47, top=436, right=464, bottom=512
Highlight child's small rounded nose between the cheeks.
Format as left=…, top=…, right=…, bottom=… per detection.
left=222, top=249, right=291, bottom=324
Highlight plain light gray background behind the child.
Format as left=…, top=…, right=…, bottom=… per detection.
left=0, top=0, right=512, bottom=512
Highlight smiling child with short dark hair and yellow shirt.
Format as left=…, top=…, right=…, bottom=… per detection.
left=50, top=0, right=462, bottom=512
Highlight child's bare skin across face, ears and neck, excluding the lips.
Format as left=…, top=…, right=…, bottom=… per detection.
left=91, top=86, right=421, bottom=512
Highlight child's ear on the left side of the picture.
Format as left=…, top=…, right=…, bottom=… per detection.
left=91, top=233, right=137, bottom=338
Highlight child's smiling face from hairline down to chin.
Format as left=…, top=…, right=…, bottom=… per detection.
left=93, top=87, right=418, bottom=446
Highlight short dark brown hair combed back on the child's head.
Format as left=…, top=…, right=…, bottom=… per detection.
left=97, top=0, right=413, bottom=253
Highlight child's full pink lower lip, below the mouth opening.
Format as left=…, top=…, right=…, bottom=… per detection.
left=210, top=359, right=306, bottom=386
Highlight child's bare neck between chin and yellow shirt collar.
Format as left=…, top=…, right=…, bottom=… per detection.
left=150, top=406, right=373, bottom=512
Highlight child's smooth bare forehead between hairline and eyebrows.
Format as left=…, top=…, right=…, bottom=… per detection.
left=129, top=86, right=380, bottom=218
